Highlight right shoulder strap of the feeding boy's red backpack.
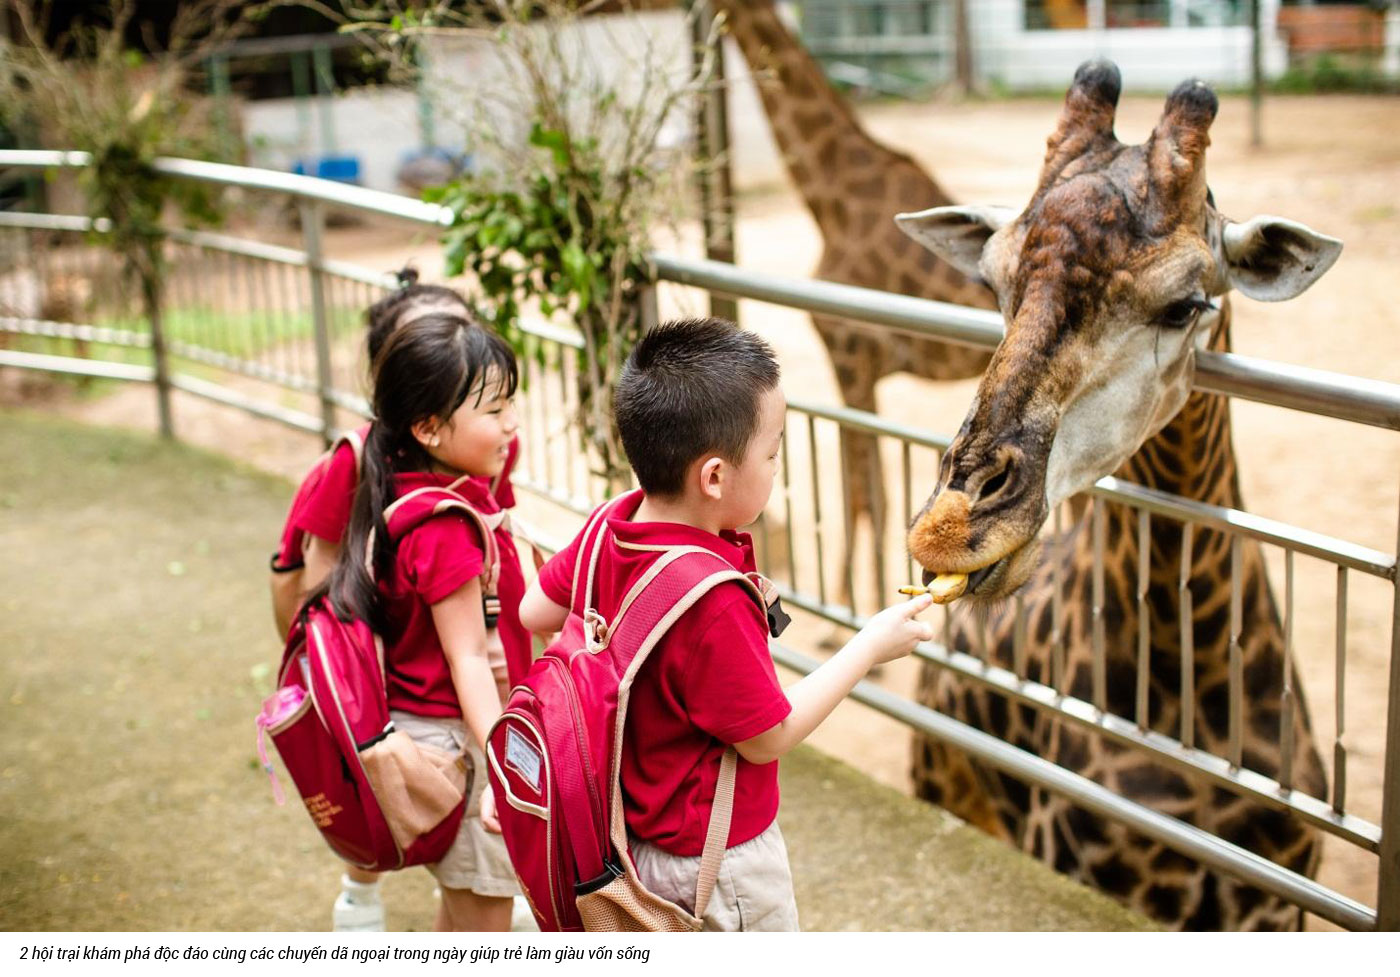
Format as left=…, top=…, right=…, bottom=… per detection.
left=588, top=546, right=767, bottom=918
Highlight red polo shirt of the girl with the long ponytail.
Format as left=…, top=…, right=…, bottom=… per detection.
left=379, top=472, right=532, bottom=717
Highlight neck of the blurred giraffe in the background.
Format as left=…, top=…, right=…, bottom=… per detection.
left=715, top=0, right=952, bottom=229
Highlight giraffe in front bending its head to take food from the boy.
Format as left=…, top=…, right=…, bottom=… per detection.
left=896, top=62, right=1341, bottom=929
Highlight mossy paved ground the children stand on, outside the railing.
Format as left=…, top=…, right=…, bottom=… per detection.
left=0, top=412, right=1147, bottom=931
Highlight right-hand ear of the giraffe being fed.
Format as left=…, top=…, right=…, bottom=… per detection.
left=1221, top=217, right=1341, bottom=302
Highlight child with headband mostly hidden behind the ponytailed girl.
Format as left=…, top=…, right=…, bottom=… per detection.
left=273, top=267, right=519, bottom=932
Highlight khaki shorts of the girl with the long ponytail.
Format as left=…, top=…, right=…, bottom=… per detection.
left=389, top=710, right=521, bottom=899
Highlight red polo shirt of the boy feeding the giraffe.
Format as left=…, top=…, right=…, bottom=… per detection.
left=539, top=493, right=792, bottom=855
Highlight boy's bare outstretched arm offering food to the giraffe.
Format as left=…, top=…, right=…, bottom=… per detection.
left=728, top=593, right=934, bottom=763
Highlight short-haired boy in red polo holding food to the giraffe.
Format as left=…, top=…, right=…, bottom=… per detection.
left=521, top=319, right=932, bottom=931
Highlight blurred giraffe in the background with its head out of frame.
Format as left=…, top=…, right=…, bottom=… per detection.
left=714, top=0, right=995, bottom=607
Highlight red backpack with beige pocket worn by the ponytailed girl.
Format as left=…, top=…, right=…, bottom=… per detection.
left=258, top=487, right=504, bottom=872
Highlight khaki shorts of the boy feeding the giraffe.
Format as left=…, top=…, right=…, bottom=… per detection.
left=629, top=822, right=799, bottom=932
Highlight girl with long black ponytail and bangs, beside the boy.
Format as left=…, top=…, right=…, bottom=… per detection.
left=326, top=312, right=531, bottom=932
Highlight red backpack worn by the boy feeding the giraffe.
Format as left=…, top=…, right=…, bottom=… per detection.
left=486, top=494, right=781, bottom=932
